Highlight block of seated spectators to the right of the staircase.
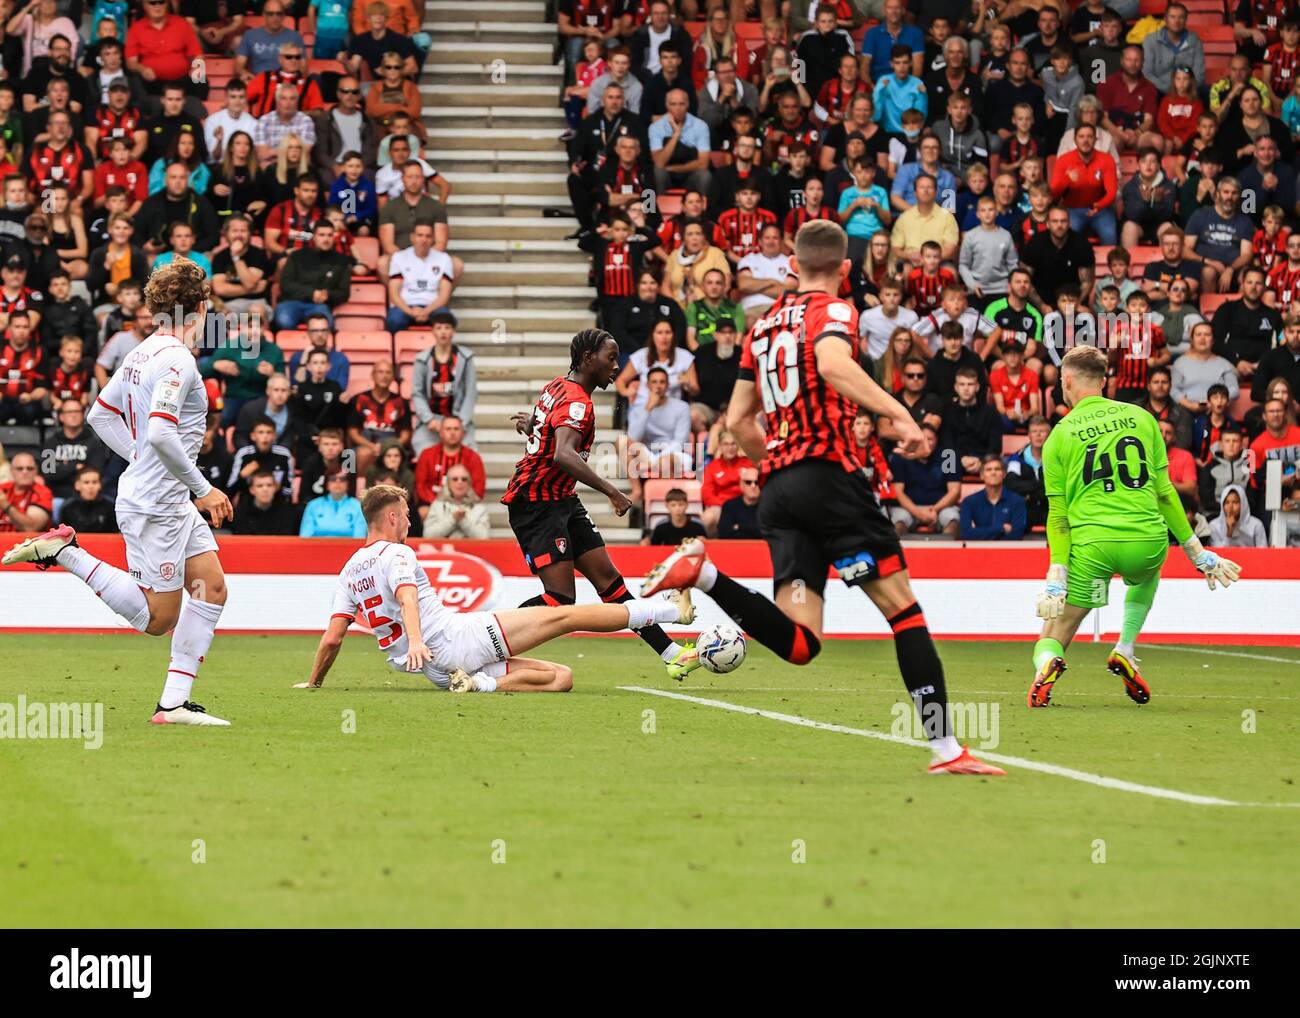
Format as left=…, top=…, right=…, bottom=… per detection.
left=559, top=0, right=1300, bottom=543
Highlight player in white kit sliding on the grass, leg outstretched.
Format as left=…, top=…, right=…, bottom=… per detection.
left=295, top=484, right=696, bottom=693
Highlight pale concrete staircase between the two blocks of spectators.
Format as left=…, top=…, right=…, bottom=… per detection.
left=420, top=0, right=640, bottom=543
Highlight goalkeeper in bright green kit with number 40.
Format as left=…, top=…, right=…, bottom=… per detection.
left=1028, top=346, right=1242, bottom=707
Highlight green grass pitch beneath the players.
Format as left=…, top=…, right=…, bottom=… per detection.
left=0, top=636, right=1300, bottom=927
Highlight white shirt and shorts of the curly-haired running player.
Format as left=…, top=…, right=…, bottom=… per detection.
left=98, top=334, right=217, bottom=593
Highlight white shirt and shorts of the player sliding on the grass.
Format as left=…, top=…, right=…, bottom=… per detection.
left=330, top=541, right=510, bottom=689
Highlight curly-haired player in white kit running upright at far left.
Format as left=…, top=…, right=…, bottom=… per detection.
left=4, top=260, right=231, bottom=725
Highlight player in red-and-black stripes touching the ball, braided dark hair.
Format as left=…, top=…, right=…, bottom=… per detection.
left=501, top=329, right=692, bottom=679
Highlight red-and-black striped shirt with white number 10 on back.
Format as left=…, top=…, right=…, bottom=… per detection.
left=737, top=290, right=867, bottom=473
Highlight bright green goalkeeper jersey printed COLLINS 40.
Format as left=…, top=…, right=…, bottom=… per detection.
left=1043, top=395, right=1169, bottom=545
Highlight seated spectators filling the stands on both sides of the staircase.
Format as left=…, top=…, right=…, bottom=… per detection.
left=0, top=0, right=1300, bottom=543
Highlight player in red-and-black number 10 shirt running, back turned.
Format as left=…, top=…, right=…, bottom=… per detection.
left=641, top=220, right=1004, bottom=775
